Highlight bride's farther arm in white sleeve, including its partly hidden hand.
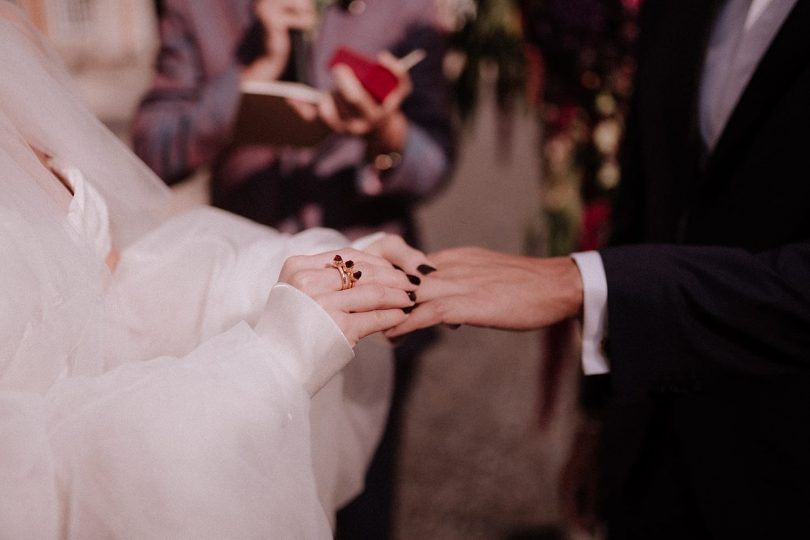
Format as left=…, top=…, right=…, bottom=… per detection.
left=110, top=207, right=432, bottom=358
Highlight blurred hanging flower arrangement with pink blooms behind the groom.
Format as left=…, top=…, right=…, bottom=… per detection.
left=438, top=0, right=642, bottom=255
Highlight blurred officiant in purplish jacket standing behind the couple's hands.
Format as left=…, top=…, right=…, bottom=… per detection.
left=132, top=0, right=454, bottom=538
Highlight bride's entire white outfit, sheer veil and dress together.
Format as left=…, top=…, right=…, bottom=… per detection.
left=0, top=1, right=391, bottom=539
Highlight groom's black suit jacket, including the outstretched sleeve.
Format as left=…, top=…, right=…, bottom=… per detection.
left=601, top=0, right=810, bottom=539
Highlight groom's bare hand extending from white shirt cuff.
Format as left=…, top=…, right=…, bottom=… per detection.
left=386, top=247, right=582, bottom=337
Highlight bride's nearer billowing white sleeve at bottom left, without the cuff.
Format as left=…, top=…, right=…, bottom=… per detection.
left=0, top=323, right=338, bottom=539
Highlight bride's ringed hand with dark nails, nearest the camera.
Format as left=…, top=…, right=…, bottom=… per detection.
left=279, top=248, right=416, bottom=346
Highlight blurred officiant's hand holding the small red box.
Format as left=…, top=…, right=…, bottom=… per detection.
left=318, top=51, right=413, bottom=153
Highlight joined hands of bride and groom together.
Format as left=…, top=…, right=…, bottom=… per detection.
left=280, top=239, right=583, bottom=345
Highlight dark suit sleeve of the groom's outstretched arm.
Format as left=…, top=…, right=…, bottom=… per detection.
left=600, top=242, right=810, bottom=397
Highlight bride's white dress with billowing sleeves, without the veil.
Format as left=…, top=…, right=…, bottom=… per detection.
left=0, top=159, right=390, bottom=539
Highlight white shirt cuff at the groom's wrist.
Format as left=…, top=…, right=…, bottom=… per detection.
left=571, top=251, right=610, bottom=375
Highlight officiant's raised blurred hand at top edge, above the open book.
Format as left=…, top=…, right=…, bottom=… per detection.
left=241, top=0, right=317, bottom=81
